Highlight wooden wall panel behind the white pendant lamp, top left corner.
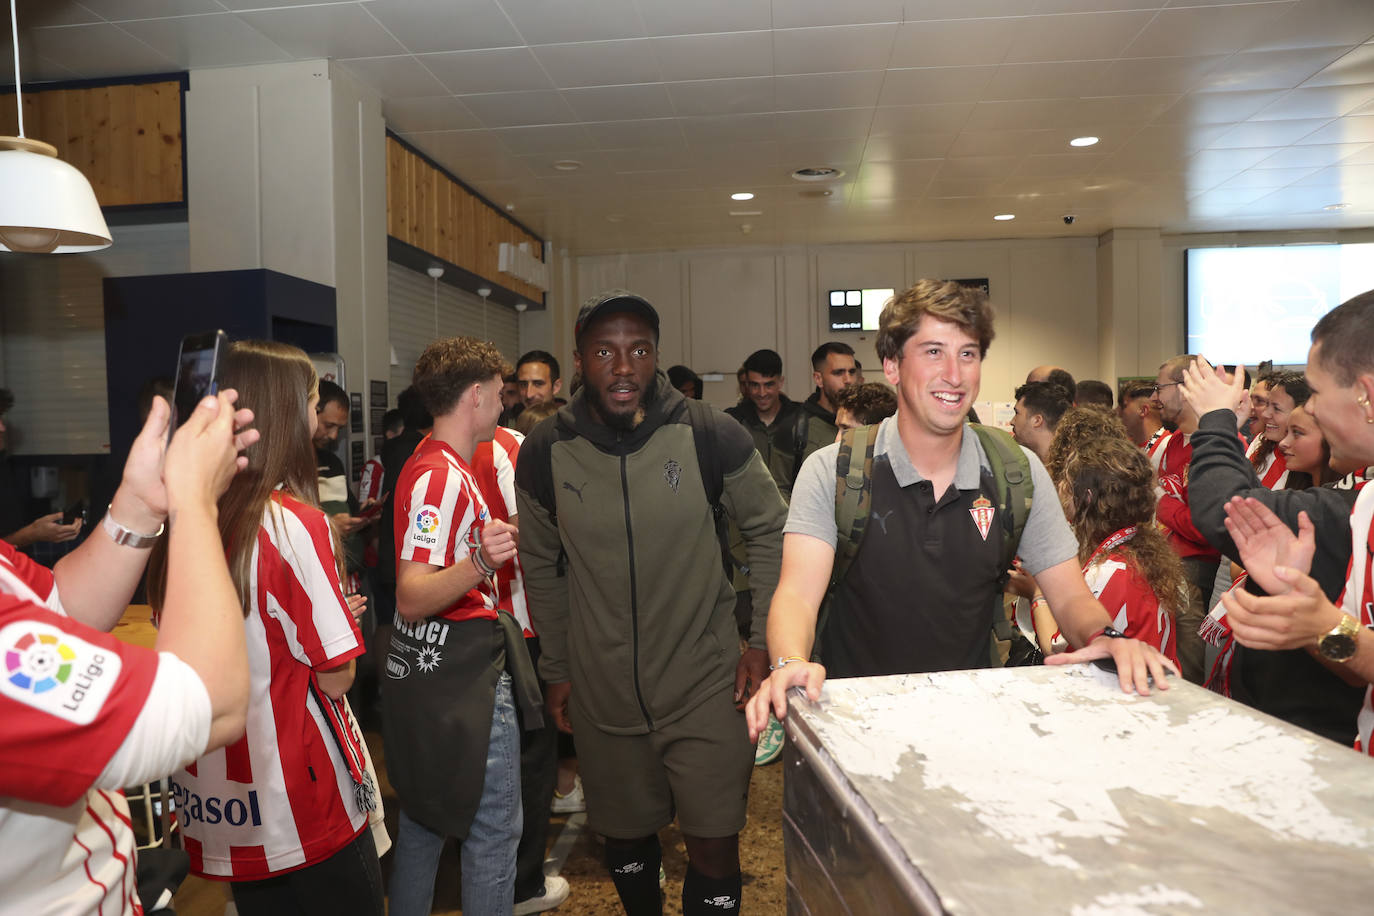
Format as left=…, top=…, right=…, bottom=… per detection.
left=0, top=81, right=185, bottom=207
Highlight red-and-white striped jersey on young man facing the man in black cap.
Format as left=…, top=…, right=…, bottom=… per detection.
left=396, top=435, right=496, bottom=621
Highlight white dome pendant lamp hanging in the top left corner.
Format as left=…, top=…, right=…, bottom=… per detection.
left=0, top=0, right=110, bottom=254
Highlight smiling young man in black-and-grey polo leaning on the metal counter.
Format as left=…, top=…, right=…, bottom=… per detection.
left=749, top=280, right=1172, bottom=736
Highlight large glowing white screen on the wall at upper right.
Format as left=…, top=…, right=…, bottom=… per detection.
left=1187, top=244, right=1374, bottom=367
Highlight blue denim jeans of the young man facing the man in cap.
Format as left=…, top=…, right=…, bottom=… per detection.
left=387, top=672, right=522, bottom=916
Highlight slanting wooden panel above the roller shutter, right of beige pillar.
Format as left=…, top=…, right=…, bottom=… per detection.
left=386, top=137, right=544, bottom=302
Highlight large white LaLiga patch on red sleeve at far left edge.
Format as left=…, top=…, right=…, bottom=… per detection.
left=0, top=621, right=122, bottom=725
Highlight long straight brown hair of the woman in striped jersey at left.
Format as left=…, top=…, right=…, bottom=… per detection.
left=148, top=341, right=342, bottom=614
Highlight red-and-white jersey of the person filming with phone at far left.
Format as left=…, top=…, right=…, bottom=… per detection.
left=0, top=544, right=174, bottom=915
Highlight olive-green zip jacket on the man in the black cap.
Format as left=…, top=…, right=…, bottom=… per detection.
left=515, top=372, right=787, bottom=735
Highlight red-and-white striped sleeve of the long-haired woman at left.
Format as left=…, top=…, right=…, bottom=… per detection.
left=258, top=499, right=363, bottom=669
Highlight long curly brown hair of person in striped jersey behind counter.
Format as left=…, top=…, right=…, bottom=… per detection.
left=1059, top=437, right=1189, bottom=615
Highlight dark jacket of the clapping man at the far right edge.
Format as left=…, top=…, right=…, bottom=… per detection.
left=1189, top=411, right=1364, bottom=744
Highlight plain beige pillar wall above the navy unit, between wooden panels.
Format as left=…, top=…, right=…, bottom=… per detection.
left=185, top=60, right=396, bottom=450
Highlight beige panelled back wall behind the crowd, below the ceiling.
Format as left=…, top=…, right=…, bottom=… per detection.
left=574, top=239, right=1099, bottom=405
